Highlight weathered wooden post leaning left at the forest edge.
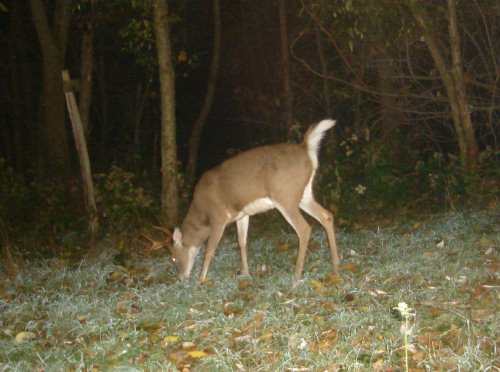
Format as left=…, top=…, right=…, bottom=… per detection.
left=62, top=70, right=99, bottom=240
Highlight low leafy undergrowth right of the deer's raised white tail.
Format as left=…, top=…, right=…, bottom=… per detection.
left=318, top=132, right=500, bottom=223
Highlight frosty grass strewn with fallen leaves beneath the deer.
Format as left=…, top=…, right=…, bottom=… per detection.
left=0, top=211, right=500, bottom=371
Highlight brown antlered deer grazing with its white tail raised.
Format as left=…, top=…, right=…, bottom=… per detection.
left=153, top=119, right=340, bottom=283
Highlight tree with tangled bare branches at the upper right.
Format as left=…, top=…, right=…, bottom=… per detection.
left=292, top=0, right=492, bottom=169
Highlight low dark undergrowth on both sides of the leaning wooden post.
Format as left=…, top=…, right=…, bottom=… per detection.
left=0, top=159, right=159, bottom=255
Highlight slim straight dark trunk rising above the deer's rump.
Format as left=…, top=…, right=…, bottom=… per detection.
left=279, top=0, right=293, bottom=137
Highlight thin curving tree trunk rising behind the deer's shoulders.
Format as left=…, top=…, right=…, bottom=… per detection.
left=186, top=0, right=221, bottom=190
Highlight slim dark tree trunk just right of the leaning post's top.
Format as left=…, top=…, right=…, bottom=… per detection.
left=78, top=21, right=94, bottom=138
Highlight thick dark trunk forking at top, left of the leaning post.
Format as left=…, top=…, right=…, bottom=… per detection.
left=30, top=0, right=71, bottom=178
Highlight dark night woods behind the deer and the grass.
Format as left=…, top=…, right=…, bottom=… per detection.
left=0, top=0, right=500, bottom=251
